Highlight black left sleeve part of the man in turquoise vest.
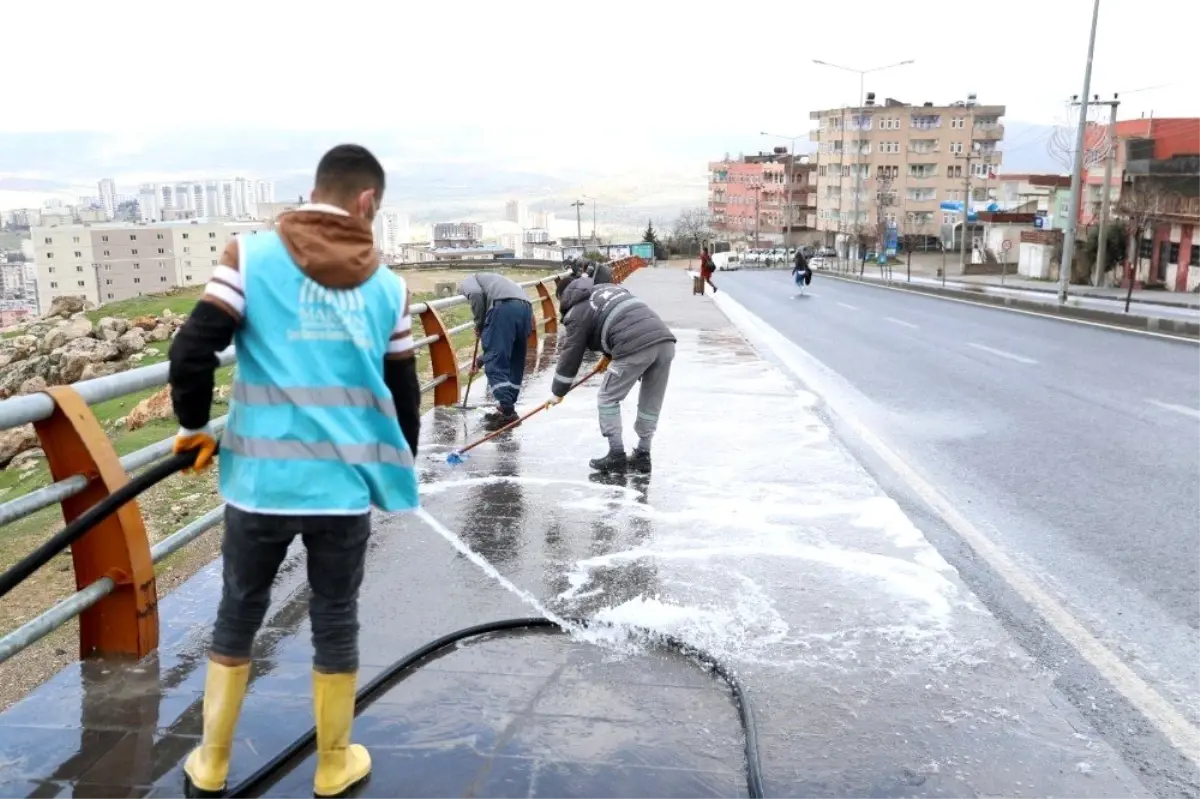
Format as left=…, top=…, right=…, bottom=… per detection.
left=168, top=300, right=238, bottom=429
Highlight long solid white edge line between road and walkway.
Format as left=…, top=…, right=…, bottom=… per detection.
left=716, top=289, right=1200, bottom=765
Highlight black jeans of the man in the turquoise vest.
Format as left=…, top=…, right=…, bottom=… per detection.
left=212, top=505, right=371, bottom=674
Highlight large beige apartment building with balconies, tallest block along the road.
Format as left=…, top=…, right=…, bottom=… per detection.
left=809, top=94, right=1004, bottom=244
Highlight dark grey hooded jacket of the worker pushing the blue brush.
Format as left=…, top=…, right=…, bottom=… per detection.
left=553, top=277, right=676, bottom=397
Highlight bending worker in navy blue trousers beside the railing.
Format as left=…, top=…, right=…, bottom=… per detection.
left=458, top=272, right=533, bottom=429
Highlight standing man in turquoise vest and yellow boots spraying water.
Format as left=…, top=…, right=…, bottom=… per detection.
left=170, top=145, right=421, bottom=797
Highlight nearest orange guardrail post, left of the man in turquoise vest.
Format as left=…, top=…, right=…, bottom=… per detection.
left=34, top=386, right=158, bottom=657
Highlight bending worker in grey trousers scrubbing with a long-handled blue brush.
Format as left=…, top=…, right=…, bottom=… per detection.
left=550, top=273, right=676, bottom=474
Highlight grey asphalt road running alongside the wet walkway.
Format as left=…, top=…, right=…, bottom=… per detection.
left=716, top=271, right=1200, bottom=795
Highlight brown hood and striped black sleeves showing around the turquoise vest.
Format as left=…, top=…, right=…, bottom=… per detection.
left=169, top=205, right=421, bottom=456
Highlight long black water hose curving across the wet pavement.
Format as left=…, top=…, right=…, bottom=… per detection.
left=0, top=443, right=764, bottom=799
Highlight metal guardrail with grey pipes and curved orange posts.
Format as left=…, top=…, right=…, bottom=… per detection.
left=0, top=257, right=646, bottom=663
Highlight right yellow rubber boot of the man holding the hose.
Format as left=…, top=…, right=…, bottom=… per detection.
left=312, top=671, right=371, bottom=799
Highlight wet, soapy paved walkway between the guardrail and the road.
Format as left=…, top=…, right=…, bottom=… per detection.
left=0, top=270, right=1145, bottom=799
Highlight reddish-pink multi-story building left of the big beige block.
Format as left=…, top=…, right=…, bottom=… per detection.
left=708, top=148, right=816, bottom=246
